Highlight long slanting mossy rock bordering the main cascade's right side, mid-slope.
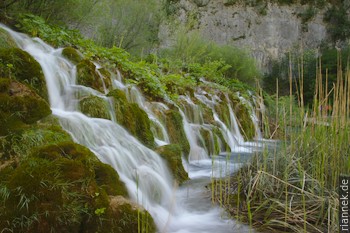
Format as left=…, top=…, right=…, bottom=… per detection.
left=108, top=90, right=154, bottom=148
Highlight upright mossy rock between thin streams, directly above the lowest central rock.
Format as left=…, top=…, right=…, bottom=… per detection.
left=165, top=110, right=190, bottom=155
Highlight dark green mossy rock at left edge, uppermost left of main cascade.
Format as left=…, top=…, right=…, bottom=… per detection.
left=0, top=48, right=48, bottom=100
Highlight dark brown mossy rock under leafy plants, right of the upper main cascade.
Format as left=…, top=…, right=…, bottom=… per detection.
left=77, top=59, right=111, bottom=93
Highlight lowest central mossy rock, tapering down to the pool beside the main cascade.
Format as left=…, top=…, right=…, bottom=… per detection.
left=156, top=144, right=188, bottom=184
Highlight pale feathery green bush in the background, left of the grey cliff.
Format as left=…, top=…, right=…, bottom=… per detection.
left=96, top=0, right=162, bottom=55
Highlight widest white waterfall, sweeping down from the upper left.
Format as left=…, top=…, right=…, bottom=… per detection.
left=5, top=25, right=178, bottom=228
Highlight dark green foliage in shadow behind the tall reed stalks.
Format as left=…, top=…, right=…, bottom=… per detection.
left=263, top=47, right=350, bottom=106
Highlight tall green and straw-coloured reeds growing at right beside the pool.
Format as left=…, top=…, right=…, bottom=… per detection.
left=212, top=50, right=350, bottom=232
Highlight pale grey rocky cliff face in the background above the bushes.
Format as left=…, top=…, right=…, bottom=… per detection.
left=159, top=0, right=328, bottom=70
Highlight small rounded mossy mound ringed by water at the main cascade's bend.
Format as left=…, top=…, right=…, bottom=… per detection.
left=79, top=96, right=111, bottom=120
